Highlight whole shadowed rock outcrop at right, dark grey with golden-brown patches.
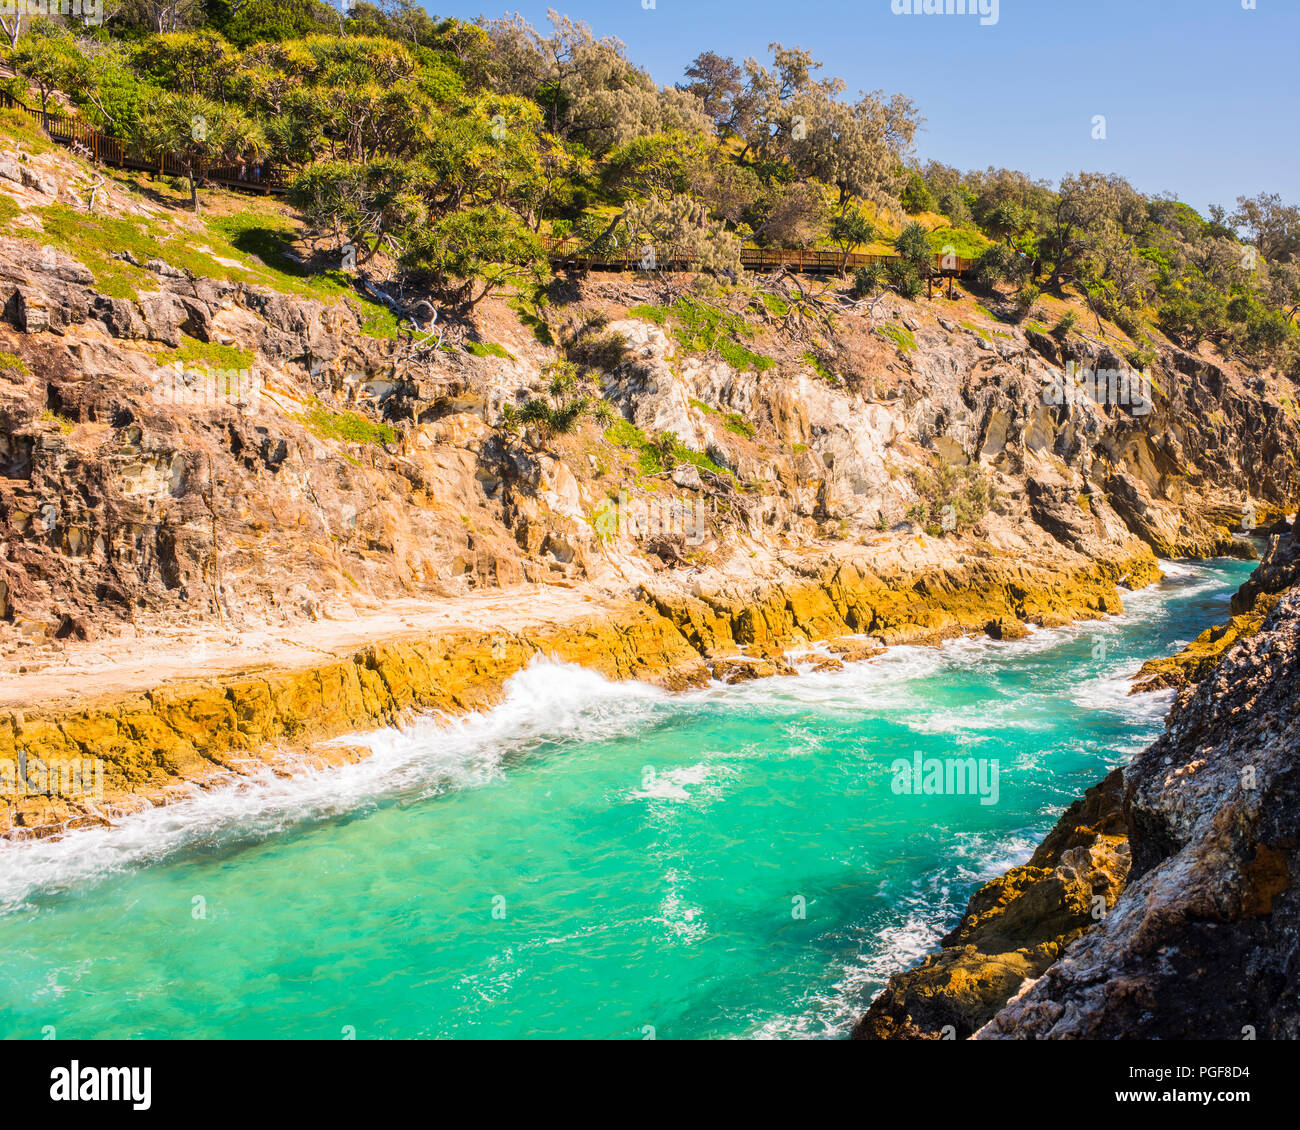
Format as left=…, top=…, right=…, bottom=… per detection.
left=854, top=531, right=1300, bottom=1039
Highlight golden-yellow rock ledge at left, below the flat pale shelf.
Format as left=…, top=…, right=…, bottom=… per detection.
left=0, top=602, right=709, bottom=839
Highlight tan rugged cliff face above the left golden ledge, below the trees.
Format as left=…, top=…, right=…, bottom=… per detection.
left=0, top=144, right=1300, bottom=655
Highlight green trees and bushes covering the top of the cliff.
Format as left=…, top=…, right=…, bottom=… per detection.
left=0, top=0, right=1300, bottom=373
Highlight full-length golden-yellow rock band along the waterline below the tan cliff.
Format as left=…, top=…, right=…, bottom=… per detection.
left=0, top=551, right=1162, bottom=839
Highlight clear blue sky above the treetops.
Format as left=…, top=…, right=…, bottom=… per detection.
left=425, top=0, right=1300, bottom=211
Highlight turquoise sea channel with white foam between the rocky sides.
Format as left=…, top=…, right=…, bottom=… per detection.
left=0, top=562, right=1251, bottom=1039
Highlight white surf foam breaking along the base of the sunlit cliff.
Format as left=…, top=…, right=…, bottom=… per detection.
left=0, top=562, right=1237, bottom=936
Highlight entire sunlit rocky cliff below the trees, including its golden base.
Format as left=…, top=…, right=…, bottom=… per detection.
left=0, top=130, right=1300, bottom=837
